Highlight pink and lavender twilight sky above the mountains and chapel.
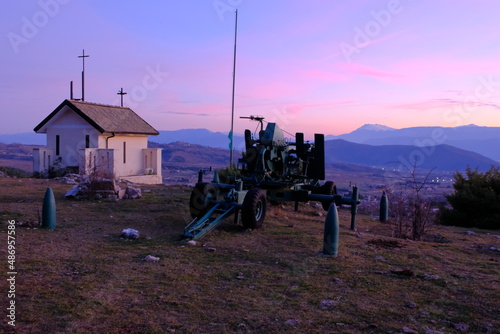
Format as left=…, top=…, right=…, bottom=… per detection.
left=0, top=0, right=500, bottom=136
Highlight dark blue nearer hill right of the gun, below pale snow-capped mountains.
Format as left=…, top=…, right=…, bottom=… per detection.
left=325, top=139, right=498, bottom=171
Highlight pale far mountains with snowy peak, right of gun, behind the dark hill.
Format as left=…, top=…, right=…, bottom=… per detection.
left=327, top=124, right=500, bottom=161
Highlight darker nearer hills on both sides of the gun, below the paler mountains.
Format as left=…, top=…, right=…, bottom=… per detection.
left=150, top=139, right=498, bottom=172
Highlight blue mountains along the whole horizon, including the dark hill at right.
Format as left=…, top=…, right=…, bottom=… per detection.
left=0, top=124, right=500, bottom=171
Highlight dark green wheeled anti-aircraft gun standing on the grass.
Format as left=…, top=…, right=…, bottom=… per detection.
left=182, top=116, right=359, bottom=239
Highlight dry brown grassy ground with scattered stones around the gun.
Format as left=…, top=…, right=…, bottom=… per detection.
left=0, top=178, right=500, bottom=333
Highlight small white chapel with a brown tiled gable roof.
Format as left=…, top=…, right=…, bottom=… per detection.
left=33, top=100, right=162, bottom=184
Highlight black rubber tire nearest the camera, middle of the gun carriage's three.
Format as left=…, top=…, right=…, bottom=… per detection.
left=241, top=188, right=267, bottom=229
